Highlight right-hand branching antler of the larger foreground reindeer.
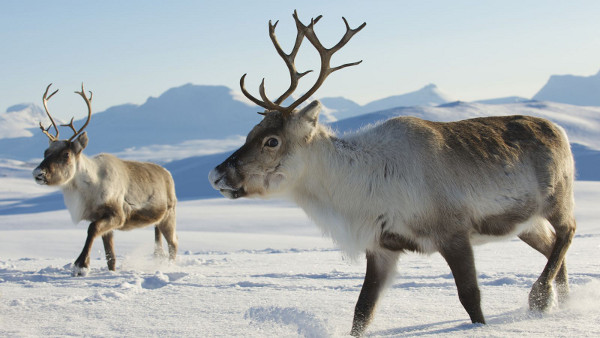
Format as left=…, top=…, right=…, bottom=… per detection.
left=287, top=17, right=367, bottom=111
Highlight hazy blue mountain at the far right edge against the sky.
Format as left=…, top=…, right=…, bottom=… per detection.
left=533, top=71, right=600, bottom=106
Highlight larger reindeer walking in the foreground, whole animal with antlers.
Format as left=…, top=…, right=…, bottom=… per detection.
left=209, top=12, right=575, bottom=336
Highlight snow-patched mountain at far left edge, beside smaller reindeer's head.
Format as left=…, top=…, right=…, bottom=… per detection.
left=0, top=103, right=63, bottom=139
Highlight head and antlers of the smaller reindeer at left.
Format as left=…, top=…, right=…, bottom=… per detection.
left=33, top=84, right=92, bottom=185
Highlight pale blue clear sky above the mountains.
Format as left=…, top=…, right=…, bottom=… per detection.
left=0, top=0, right=600, bottom=119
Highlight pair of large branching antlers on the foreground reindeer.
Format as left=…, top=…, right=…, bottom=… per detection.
left=240, top=11, right=367, bottom=115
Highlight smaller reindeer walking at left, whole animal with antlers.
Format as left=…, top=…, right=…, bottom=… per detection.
left=33, top=84, right=177, bottom=276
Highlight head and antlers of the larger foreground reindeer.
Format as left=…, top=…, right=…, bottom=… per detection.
left=209, top=11, right=366, bottom=198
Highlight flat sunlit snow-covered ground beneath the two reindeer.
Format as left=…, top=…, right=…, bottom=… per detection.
left=0, top=161, right=600, bottom=337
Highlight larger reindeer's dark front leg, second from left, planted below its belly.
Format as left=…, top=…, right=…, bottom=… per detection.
left=440, top=234, right=485, bottom=324
